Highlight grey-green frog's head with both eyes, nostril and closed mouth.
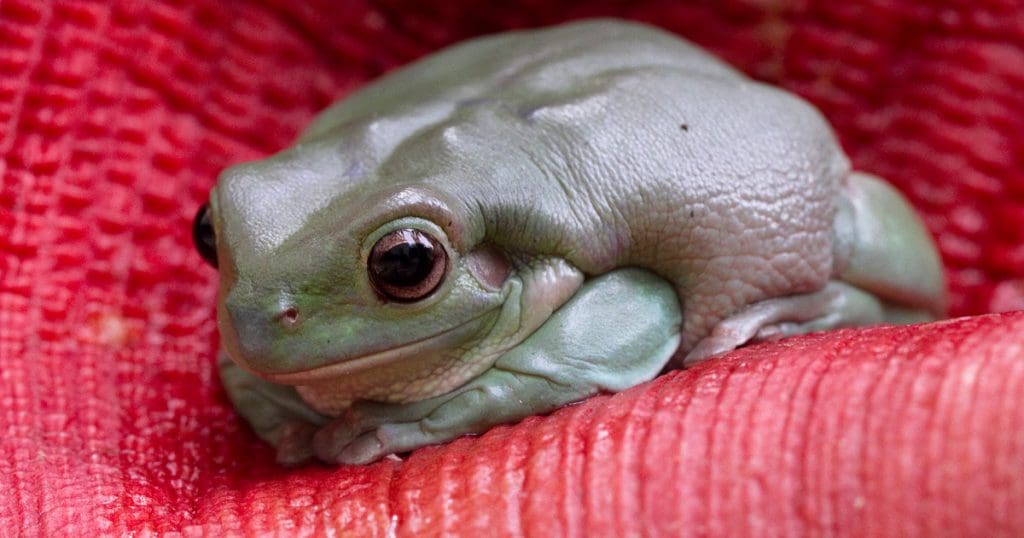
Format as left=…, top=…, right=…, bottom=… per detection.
left=194, top=142, right=536, bottom=384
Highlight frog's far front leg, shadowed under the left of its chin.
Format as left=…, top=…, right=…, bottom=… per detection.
left=217, top=351, right=329, bottom=465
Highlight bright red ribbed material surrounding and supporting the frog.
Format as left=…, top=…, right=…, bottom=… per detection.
left=0, top=0, right=1024, bottom=536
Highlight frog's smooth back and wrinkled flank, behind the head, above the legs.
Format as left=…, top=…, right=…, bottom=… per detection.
left=300, top=20, right=849, bottom=347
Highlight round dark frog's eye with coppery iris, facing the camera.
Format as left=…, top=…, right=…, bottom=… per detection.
left=367, top=227, right=447, bottom=302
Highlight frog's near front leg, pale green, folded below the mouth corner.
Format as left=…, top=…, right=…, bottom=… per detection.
left=313, top=268, right=681, bottom=464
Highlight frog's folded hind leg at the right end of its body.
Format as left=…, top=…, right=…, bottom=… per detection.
left=683, top=173, right=945, bottom=366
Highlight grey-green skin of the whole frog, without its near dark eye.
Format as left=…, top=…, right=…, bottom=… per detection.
left=203, top=20, right=945, bottom=463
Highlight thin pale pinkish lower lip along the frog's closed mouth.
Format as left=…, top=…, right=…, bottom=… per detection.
left=260, top=309, right=498, bottom=385
